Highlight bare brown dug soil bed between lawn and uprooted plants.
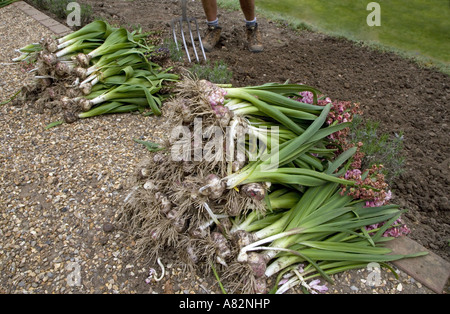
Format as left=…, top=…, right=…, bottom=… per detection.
left=32, top=0, right=450, bottom=260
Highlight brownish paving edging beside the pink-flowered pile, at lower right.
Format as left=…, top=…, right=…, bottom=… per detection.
left=386, top=237, right=450, bottom=293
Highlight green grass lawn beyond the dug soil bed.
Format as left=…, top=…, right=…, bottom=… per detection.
left=219, top=0, right=450, bottom=72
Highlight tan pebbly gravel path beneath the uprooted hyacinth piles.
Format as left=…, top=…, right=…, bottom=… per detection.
left=0, top=6, right=440, bottom=294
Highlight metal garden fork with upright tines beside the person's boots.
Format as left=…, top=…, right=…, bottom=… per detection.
left=171, top=0, right=206, bottom=62
